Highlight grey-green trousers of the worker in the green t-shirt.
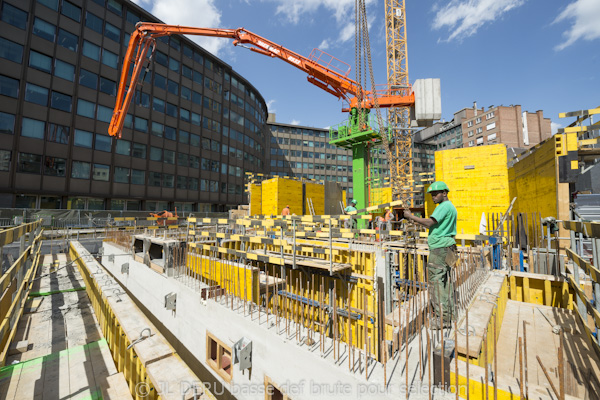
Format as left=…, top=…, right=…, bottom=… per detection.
left=427, top=245, right=458, bottom=323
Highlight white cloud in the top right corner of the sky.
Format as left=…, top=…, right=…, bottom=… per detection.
left=554, top=0, right=600, bottom=50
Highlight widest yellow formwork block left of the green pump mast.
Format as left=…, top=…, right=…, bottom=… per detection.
left=262, top=178, right=302, bottom=215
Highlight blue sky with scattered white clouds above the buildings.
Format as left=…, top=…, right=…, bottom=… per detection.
left=134, top=0, right=600, bottom=133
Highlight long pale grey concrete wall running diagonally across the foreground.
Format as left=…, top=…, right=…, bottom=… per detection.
left=102, top=243, right=403, bottom=400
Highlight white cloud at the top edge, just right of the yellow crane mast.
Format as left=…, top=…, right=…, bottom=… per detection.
left=433, top=0, right=524, bottom=41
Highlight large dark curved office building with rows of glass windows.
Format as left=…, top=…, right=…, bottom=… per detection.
left=0, top=0, right=270, bottom=211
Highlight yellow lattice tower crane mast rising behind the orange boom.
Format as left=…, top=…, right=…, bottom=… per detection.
left=385, top=0, right=413, bottom=208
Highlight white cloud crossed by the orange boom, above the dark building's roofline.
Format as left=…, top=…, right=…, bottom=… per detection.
left=133, top=0, right=229, bottom=56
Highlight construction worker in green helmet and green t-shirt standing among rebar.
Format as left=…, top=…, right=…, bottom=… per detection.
left=404, top=181, right=458, bottom=329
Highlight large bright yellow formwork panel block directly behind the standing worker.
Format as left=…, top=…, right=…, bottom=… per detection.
left=435, top=144, right=510, bottom=234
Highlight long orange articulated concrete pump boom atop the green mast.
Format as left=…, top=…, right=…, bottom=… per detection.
left=108, top=22, right=415, bottom=138
